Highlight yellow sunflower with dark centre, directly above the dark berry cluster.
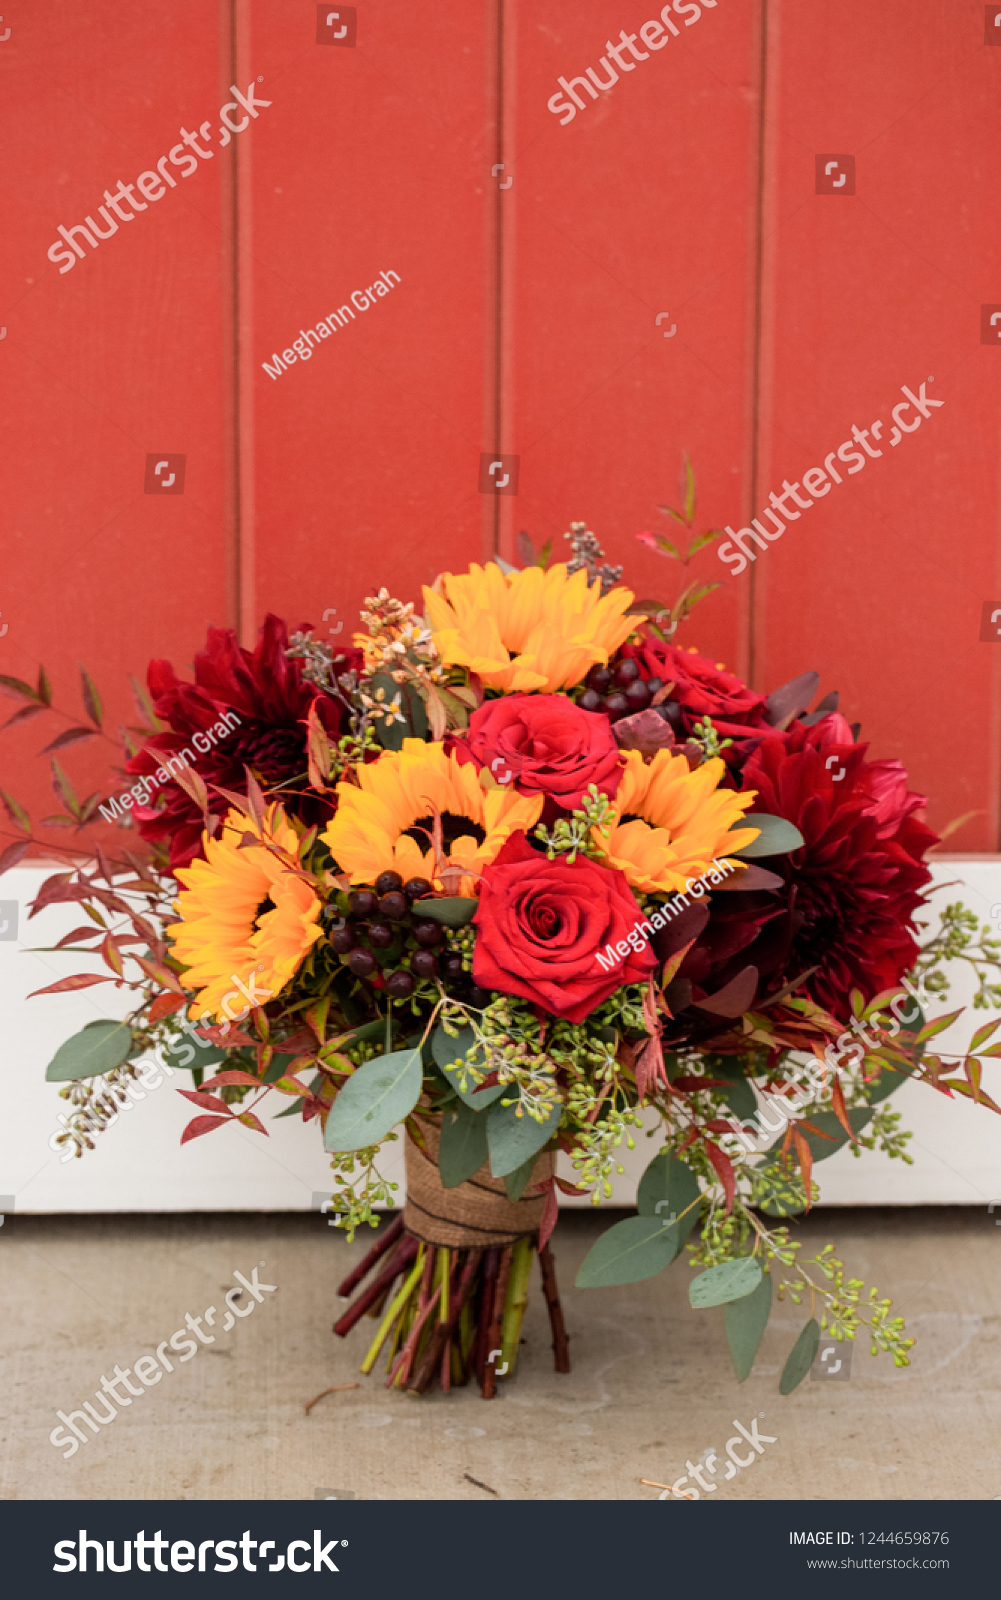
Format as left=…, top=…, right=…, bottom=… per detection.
left=323, top=739, right=544, bottom=894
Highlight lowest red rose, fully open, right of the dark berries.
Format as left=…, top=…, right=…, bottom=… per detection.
left=473, top=832, right=657, bottom=1022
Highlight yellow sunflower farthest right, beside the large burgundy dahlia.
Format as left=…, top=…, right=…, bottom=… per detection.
left=593, top=750, right=760, bottom=893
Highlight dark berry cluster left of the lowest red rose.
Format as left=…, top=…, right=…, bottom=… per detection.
left=329, top=872, right=489, bottom=1006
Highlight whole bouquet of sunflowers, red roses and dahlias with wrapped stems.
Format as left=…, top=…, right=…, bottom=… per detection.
left=9, top=523, right=1001, bottom=1397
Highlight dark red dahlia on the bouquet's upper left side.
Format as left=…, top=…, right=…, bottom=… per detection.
left=126, top=613, right=361, bottom=867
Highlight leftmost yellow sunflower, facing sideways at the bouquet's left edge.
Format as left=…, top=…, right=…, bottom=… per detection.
left=168, top=805, right=323, bottom=1021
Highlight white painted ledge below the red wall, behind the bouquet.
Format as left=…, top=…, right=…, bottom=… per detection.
left=0, top=856, right=1001, bottom=1214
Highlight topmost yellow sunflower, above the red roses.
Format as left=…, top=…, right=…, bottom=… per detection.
left=424, top=562, right=636, bottom=693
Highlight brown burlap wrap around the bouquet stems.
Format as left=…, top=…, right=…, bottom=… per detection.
left=403, top=1117, right=555, bottom=1250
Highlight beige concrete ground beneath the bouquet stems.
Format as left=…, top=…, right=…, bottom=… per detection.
left=0, top=1208, right=1001, bottom=1515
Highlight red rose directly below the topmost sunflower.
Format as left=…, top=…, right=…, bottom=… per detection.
left=456, top=694, right=622, bottom=811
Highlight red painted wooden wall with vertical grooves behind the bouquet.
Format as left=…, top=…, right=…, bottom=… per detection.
left=0, top=0, right=1001, bottom=850
